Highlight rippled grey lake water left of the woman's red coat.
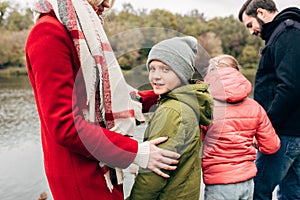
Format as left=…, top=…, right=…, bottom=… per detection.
left=0, top=76, right=51, bottom=200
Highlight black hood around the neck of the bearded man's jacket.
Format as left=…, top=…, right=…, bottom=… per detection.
left=261, top=7, right=300, bottom=41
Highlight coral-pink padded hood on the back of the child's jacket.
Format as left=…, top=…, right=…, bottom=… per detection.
left=205, top=67, right=252, bottom=103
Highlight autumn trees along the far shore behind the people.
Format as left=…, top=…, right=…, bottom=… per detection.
left=0, top=2, right=262, bottom=82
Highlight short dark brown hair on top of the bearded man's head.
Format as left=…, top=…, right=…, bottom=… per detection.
left=239, top=0, right=278, bottom=22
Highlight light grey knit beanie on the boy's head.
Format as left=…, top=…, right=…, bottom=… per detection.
left=146, top=36, right=198, bottom=83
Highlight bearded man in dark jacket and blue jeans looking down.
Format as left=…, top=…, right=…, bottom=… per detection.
left=239, top=0, right=300, bottom=200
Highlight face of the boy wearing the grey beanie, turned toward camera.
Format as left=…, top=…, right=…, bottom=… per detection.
left=149, top=60, right=181, bottom=95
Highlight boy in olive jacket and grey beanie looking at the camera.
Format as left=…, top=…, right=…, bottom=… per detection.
left=128, top=36, right=212, bottom=200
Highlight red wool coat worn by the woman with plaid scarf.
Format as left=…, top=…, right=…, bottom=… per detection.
left=26, top=14, right=138, bottom=200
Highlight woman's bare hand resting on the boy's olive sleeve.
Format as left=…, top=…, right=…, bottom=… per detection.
left=147, top=137, right=180, bottom=178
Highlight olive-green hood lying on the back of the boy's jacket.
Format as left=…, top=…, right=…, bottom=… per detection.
left=159, top=83, right=213, bottom=126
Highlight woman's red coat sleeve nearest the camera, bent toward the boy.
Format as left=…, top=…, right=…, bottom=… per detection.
left=26, top=15, right=138, bottom=168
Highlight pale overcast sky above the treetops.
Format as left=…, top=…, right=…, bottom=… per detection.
left=15, top=0, right=300, bottom=19
